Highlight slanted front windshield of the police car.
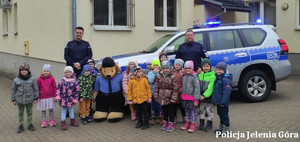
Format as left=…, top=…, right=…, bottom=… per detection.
left=142, top=34, right=175, bottom=53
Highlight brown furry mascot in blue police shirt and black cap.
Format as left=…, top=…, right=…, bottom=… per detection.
left=93, top=57, right=125, bottom=122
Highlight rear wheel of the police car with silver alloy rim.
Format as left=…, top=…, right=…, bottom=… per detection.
left=239, top=70, right=271, bottom=102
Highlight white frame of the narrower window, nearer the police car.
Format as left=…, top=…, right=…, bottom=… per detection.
left=154, top=0, right=179, bottom=31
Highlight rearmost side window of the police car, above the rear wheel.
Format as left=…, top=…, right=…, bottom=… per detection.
left=240, top=28, right=266, bottom=46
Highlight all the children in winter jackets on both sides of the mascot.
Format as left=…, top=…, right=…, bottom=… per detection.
left=11, top=52, right=232, bottom=133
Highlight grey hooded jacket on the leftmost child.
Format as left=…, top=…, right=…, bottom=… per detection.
left=11, top=76, right=39, bottom=105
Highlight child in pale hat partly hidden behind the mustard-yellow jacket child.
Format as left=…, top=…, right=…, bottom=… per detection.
left=122, top=59, right=138, bottom=120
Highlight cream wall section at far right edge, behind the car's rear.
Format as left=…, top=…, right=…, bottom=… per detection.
left=276, top=0, right=300, bottom=53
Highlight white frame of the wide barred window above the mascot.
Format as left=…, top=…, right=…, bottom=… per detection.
left=93, top=0, right=135, bottom=31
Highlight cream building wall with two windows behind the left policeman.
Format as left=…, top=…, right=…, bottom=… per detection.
left=0, top=0, right=253, bottom=62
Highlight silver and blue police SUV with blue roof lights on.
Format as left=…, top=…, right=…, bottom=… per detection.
left=99, top=23, right=291, bottom=102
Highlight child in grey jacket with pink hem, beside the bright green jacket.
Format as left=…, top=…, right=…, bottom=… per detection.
left=181, top=60, right=200, bottom=133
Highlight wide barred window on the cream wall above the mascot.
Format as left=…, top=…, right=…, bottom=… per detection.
left=94, top=0, right=135, bottom=30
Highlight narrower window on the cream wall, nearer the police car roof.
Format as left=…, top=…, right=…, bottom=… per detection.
left=154, top=0, right=177, bottom=30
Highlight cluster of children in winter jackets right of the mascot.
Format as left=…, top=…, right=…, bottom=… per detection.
left=123, top=52, right=232, bottom=133
